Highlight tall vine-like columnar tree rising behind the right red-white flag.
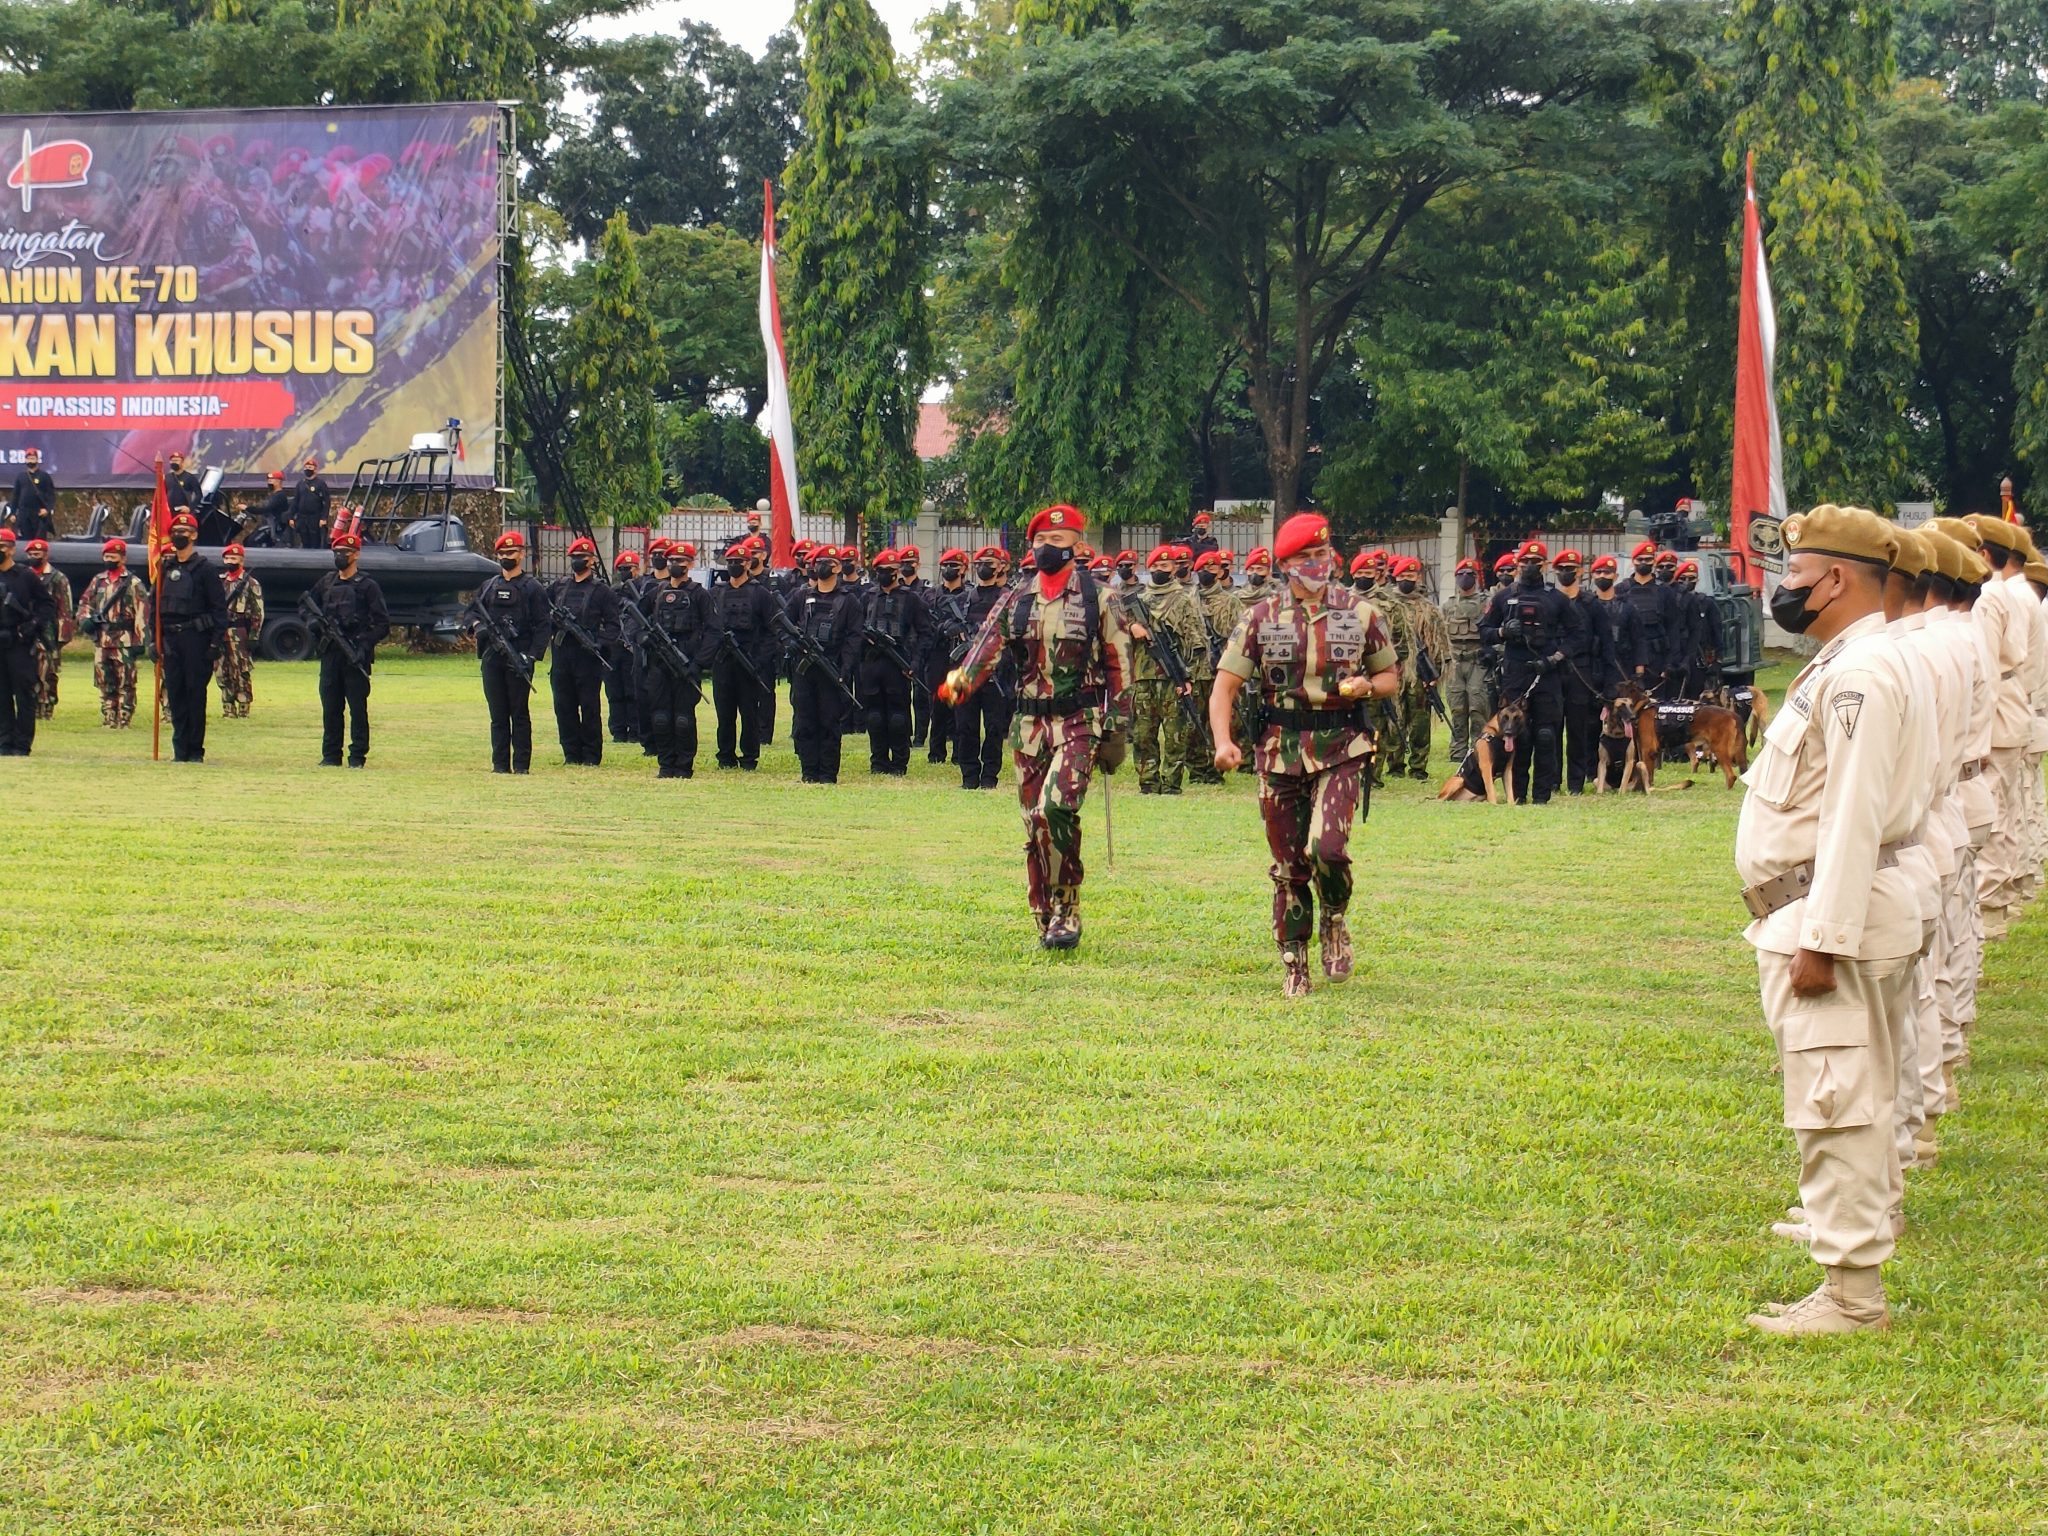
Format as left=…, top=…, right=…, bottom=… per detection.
left=1726, top=0, right=1917, bottom=504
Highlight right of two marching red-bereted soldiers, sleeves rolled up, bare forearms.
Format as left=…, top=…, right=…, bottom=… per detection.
left=1208, top=512, right=1399, bottom=997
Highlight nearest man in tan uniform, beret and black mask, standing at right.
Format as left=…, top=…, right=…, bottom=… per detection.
left=1735, top=506, right=1933, bottom=1333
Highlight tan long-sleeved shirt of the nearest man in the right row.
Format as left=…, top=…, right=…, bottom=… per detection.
left=1735, top=612, right=1933, bottom=961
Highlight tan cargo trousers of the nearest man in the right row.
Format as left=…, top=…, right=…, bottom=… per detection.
left=1757, top=950, right=1915, bottom=1268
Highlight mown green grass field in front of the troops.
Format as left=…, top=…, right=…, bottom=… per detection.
left=0, top=653, right=2048, bottom=1536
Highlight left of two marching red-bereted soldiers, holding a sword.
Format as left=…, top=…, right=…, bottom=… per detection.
left=942, top=506, right=1130, bottom=950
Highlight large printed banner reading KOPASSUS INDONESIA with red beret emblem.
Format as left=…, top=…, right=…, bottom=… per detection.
left=0, top=106, right=500, bottom=487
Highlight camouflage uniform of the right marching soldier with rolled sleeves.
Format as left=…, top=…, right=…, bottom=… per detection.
left=1219, top=584, right=1395, bottom=952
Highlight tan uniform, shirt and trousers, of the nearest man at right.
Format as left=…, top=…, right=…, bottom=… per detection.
left=1735, top=614, right=1933, bottom=1268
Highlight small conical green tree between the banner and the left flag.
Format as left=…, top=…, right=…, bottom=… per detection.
left=565, top=213, right=664, bottom=526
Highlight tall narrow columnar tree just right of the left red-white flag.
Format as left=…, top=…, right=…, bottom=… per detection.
left=780, top=0, right=930, bottom=526
